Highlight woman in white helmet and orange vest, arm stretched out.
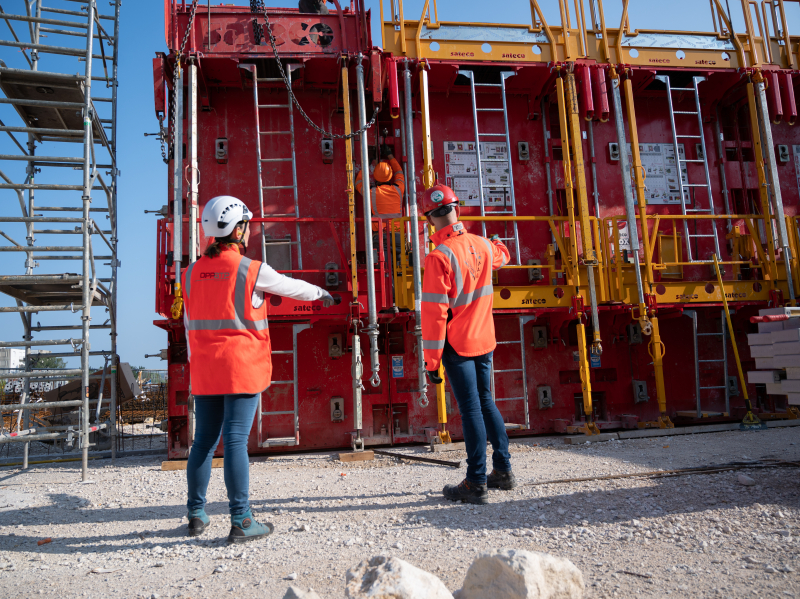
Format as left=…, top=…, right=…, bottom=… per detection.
left=183, top=196, right=334, bottom=543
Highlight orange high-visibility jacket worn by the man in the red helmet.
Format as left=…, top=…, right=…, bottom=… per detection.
left=421, top=222, right=510, bottom=370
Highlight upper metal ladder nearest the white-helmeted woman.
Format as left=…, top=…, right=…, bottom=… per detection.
left=247, top=64, right=303, bottom=270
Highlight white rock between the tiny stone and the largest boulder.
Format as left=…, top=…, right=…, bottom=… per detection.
left=345, top=555, right=453, bottom=599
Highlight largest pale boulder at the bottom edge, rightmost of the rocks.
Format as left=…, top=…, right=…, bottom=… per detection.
left=455, top=549, right=584, bottom=599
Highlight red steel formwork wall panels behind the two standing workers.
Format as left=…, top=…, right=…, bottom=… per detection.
left=156, top=7, right=800, bottom=458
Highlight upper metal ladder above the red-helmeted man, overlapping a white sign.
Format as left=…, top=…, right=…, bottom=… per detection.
left=458, top=71, right=521, bottom=266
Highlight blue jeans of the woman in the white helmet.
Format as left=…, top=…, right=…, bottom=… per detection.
left=186, top=394, right=260, bottom=516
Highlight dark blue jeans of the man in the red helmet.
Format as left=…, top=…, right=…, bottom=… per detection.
left=442, top=343, right=511, bottom=485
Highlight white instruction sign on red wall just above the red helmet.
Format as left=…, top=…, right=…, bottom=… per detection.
left=444, top=141, right=511, bottom=207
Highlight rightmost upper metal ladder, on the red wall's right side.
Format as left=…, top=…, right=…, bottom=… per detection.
left=656, top=75, right=722, bottom=264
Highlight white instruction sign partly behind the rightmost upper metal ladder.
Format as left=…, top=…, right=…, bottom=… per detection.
left=628, top=143, right=691, bottom=204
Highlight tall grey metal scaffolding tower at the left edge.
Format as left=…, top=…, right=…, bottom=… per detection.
left=0, top=0, right=121, bottom=480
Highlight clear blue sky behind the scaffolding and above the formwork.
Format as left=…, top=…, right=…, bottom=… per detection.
left=0, top=0, right=800, bottom=368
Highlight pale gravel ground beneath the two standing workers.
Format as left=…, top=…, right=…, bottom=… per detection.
left=0, top=427, right=800, bottom=599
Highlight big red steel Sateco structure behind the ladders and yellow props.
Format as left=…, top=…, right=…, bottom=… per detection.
left=154, top=0, right=800, bottom=458
